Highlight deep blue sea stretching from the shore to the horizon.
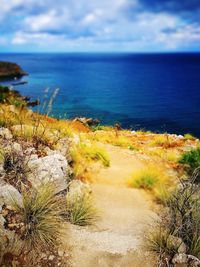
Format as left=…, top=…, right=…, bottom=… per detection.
left=0, top=54, right=200, bottom=136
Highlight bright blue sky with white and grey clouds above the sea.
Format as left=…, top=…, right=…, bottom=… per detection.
left=0, top=0, right=200, bottom=52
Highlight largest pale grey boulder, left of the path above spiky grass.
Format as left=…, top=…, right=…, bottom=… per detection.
left=28, top=154, right=70, bottom=193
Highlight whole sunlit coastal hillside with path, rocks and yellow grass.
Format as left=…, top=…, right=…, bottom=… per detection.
left=0, top=87, right=200, bottom=267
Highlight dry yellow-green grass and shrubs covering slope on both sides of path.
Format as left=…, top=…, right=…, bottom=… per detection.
left=0, top=86, right=200, bottom=267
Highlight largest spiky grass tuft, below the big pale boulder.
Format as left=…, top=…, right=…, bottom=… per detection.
left=14, top=184, right=63, bottom=251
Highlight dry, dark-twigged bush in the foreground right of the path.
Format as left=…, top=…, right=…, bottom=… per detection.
left=148, top=176, right=200, bottom=266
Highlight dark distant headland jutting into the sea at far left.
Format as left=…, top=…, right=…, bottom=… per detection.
left=0, top=61, right=28, bottom=80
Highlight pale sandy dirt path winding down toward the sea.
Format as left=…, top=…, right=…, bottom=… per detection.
left=65, top=145, right=156, bottom=267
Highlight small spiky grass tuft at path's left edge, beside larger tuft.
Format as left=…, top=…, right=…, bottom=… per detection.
left=66, top=194, right=97, bottom=226
